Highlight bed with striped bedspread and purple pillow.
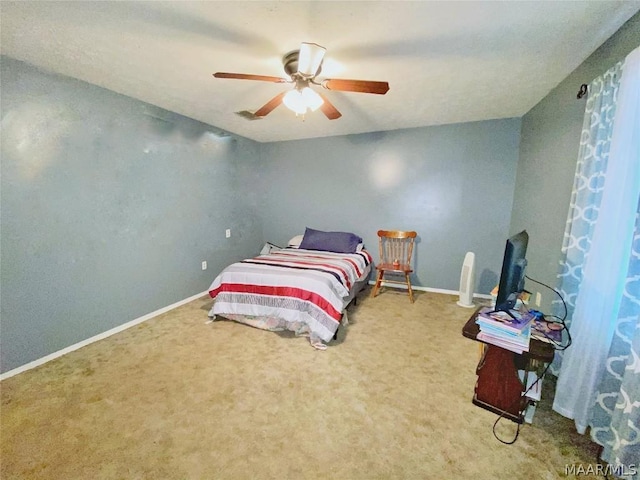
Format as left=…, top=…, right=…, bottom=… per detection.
left=209, top=228, right=372, bottom=349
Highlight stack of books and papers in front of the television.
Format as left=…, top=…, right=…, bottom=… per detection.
left=476, top=307, right=534, bottom=353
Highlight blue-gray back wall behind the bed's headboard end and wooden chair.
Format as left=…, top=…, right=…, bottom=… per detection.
left=261, top=119, right=520, bottom=293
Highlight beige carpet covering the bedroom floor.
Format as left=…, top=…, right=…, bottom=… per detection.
left=1, top=289, right=596, bottom=480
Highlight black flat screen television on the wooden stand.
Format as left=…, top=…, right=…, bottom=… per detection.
left=495, top=230, right=529, bottom=313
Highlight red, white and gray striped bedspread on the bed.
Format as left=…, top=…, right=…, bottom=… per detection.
left=209, top=248, right=371, bottom=342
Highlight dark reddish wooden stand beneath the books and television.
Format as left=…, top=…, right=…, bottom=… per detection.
left=462, top=308, right=555, bottom=423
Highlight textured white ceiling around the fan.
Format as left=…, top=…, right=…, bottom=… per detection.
left=0, top=0, right=640, bottom=142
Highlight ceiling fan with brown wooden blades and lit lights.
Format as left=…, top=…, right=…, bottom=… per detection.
left=213, top=42, right=389, bottom=120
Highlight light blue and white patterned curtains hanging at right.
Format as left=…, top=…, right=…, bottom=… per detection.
left=553, top=48, right=640, bottom=479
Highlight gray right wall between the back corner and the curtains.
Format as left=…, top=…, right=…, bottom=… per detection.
left=511, top=13, right=640, bottom=311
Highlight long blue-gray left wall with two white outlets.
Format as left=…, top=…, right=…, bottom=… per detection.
left=0, top=56, right=263, bottom=372
